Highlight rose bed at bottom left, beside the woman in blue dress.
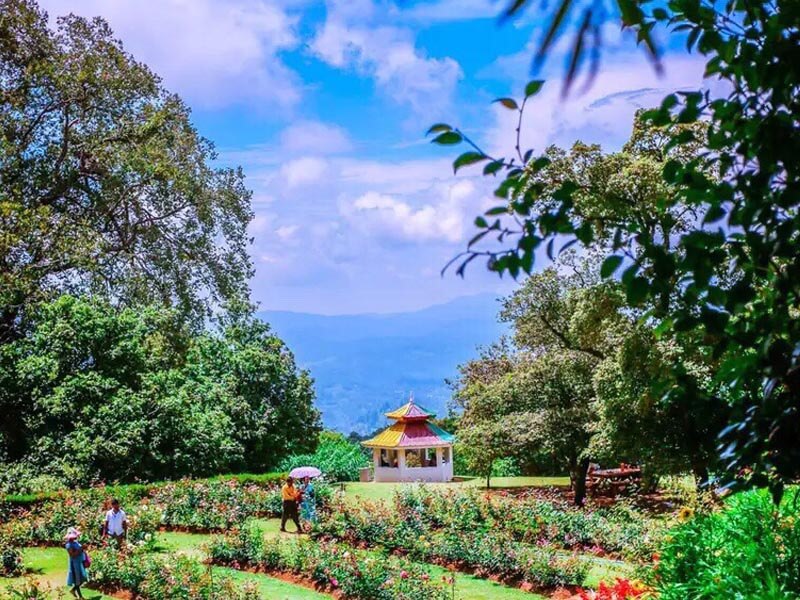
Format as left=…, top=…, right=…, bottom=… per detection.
left=91, top=550, right=261, bottom=600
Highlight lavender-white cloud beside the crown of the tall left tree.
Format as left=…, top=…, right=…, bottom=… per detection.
left=40, top=0, right=301, bottom=107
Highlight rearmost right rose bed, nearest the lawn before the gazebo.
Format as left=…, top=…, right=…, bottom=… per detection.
left=393, top=486, right=664, bottom=560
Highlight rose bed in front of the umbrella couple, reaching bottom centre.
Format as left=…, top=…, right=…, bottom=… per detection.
left=209, top=527, right=450, bottom=600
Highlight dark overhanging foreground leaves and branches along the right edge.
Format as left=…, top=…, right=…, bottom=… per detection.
left=432, top=0, right=800, bottom=501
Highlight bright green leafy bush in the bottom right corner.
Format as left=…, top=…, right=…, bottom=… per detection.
left=655, top=488, right=800, bottom=600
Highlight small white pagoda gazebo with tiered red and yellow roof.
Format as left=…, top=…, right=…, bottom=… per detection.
left=362, top=397, right=454, bottom=482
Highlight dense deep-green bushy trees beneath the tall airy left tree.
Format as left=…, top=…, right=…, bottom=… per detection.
left=0, top=296, right=319, bottom=492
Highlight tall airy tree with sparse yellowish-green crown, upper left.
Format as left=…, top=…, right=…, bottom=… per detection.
left=0, top=0, right=252, bottom=342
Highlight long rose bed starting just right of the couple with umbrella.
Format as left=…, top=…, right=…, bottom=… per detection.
left=314, top=494, right=589, bottom=589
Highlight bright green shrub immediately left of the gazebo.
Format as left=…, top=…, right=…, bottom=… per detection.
left=278, top=431, right=370, bottom=481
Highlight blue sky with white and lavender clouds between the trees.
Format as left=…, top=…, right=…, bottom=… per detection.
left=40, top=0, right=704, bottom=314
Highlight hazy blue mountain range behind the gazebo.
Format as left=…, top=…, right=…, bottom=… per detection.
left=259, top=294, right=505, bottom=433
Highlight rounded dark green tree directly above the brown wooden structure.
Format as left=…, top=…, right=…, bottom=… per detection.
left=591, top=325, right=728, bottom=485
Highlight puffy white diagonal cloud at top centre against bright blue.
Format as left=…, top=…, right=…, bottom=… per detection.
left=311, top=2, right=462, bottom=115
